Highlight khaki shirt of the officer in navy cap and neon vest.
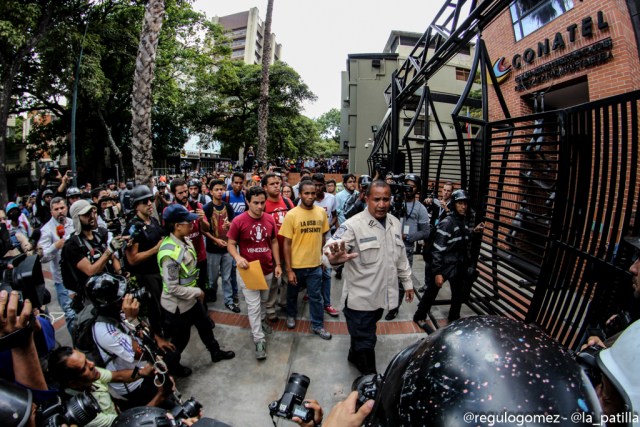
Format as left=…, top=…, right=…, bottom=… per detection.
left=160, top=234, right=201, bottom=313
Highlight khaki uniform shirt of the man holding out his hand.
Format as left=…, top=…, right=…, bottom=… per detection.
left=323, top=209, right=413, bottom=311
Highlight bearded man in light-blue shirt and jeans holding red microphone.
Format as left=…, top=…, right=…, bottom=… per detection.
left=40, top=197, right=76, bottom=336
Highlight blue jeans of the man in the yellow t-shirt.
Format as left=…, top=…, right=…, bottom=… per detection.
left=287, top=266, right=324, bottom=329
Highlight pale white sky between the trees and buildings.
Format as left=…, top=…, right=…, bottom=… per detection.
left=193, top=0, right=443, bottom=118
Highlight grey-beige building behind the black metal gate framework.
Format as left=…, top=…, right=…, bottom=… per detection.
left=340, top=30, right=480, bottom=174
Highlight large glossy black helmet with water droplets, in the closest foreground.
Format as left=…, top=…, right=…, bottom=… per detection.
left=365, top=316, right=600, bottom=426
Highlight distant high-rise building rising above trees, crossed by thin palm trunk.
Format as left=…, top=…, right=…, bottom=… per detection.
left=213, top=7, right=282, bottom=64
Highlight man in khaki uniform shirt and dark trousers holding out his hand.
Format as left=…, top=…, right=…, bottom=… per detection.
left=323, top=181, right=413, bottom=374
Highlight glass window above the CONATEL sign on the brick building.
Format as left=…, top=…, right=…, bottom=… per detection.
left=510, top=0, right=573, bottom=41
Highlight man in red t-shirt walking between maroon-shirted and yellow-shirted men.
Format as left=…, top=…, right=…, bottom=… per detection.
left=262, top=173, right=294, bottom=322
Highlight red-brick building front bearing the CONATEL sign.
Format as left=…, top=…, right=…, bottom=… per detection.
left=483, top=0, right=640, bottom=119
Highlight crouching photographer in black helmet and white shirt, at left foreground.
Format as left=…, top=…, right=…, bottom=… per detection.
left=86, top=274, right=175, bottom=408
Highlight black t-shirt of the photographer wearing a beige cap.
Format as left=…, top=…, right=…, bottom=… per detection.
left=62, top=227, right=114, bottom=286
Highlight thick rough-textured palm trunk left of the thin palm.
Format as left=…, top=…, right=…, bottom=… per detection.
left=131, top=0, right=165, bottom=186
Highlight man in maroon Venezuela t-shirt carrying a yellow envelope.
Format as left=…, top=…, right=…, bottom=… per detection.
left=227, top=186, right=282, bottom=360
